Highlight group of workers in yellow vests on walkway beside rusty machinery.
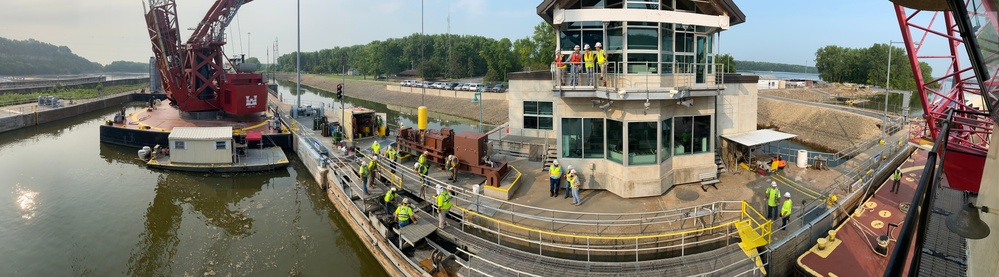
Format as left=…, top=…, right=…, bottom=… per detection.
left=358, top=141, right=460, bottom=231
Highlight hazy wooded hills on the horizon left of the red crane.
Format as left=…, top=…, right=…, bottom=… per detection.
left=0, top=37, right=149, bottom=76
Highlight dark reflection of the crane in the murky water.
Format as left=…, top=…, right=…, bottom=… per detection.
left=128, top=170, right=290, bottom=276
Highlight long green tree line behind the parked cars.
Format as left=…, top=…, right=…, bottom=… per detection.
left=275, top=22, right=556, bottom=81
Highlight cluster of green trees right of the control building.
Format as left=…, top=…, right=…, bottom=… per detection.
left=815, top=43, right=938, bottom=90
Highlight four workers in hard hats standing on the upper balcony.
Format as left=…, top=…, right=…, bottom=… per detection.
left=555, top=42, right=607, bottom=86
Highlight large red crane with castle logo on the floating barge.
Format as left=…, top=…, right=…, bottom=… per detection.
left=146, top=0, right=267, bottom=115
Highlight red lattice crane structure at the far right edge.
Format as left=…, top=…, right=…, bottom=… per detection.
left=893, top=0, right=995, bottom=192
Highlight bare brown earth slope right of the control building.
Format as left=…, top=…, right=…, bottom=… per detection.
left=757, top=98, right=881, bottom=152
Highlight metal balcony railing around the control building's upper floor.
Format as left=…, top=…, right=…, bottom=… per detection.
left=551, top=62, right=725, bottom=92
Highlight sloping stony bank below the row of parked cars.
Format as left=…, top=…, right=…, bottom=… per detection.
left=283, top=75, right=510, bottom=124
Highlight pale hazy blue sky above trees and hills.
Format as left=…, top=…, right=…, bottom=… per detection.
left=0, top=0, right=932, bottom=69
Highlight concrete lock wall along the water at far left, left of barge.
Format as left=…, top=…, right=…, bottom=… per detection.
left=0, top=94, right=132, bottom=133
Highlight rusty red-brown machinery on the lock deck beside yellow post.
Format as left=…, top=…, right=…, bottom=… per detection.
left=396, top=127, right=510, bottom=186
